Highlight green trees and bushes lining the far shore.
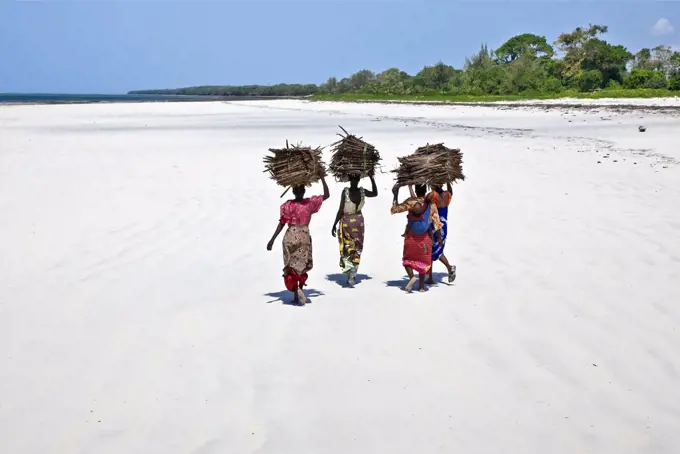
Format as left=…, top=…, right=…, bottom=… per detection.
left=133, top=25, right=680, bottom=100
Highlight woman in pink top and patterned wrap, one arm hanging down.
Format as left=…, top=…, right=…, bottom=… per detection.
left=267, top=177, right=330, bottom=305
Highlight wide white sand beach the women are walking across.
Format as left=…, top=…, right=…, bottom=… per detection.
left=0, top=100, right=680, bottom=454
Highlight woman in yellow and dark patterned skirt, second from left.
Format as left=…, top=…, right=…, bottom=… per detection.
left=331, top=172, right=378, bottom=287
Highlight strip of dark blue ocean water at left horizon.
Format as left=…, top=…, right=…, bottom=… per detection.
left=0, top=93, right=223, bottom=104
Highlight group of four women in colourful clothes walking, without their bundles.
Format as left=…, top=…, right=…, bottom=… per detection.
left=267, top=175, right=456, bottom=305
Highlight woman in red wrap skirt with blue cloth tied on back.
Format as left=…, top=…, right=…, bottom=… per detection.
left=390, top=185, right=442, bottom=292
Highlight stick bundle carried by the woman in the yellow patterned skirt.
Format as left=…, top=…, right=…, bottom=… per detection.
left=328, top=126, right=382, bottom=182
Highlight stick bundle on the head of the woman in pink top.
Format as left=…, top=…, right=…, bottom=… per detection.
left=264, top=141, right=326, bottom=187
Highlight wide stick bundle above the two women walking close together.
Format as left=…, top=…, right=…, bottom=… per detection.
left=392, top=143, right=465, bottom=186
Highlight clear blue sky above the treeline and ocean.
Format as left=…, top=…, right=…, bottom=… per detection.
left=0, top=0, right=680, bottom=93
